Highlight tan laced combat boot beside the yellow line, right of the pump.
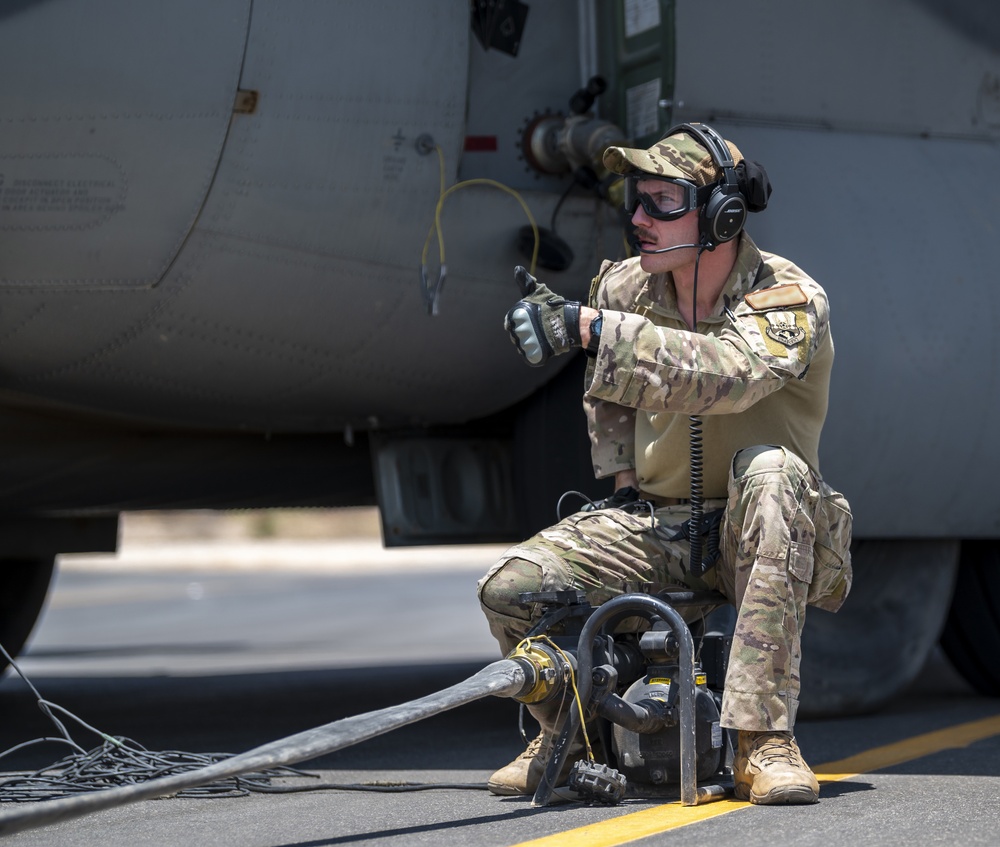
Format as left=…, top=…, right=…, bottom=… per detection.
left=733, top=729, right=819, bottom=805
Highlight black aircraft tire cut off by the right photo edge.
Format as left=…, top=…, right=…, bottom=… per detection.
left=941, top=540, right=1000, bottom=697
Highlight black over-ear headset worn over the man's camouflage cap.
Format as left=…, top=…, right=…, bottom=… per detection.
left=660, top=123, right=771, bottom=250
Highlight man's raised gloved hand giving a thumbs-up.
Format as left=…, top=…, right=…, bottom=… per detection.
left=503, top=265, right=580, bottom=366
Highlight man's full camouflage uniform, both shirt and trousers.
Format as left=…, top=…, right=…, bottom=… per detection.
left=479, top=233, right=851, bottom=730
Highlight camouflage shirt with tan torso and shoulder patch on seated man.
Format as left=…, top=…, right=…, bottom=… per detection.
left=584, top=233, right=833, bottom=498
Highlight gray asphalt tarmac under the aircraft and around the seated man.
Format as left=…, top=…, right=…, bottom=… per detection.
left=0, top=542, right=1000, bottom=847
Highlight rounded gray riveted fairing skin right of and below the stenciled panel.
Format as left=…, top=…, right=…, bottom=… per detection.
left=0, top=0, right=594, bottom=431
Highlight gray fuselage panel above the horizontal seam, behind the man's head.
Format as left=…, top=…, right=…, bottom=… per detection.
left=676, top=0, right=1000, bottom=137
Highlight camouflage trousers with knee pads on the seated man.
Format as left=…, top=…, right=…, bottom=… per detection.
left=479, top=446, right=852, bottom=730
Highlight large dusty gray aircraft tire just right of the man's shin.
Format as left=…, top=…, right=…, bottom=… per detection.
left=799, top=540, right=960, bottom=717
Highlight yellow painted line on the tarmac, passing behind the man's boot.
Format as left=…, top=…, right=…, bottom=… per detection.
left=514, top=715, right=1000, bottom=847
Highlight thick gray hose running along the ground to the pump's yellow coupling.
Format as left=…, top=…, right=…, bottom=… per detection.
left=0, top=659, right=533, bottom=836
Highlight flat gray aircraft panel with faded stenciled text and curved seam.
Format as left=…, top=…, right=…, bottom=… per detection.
left=0, top=0, right=249, bottom=289
